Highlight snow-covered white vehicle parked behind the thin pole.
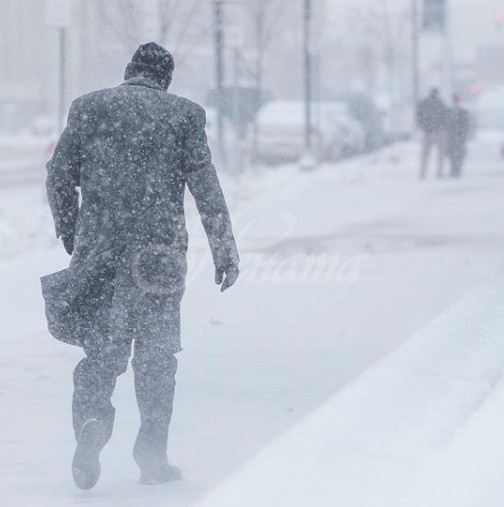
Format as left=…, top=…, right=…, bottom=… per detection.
left=256, top=101, right=365, bottom=163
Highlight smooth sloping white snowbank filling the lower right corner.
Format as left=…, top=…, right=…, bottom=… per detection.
left=195, top=274, right=504, bottom=507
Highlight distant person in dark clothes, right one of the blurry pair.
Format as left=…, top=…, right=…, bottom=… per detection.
left=446, top=95, right=471, bottom=178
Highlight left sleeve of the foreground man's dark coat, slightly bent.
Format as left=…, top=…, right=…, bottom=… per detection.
left=46, top=102, right=81, bottom=241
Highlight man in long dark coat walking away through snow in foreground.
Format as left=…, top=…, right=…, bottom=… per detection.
left=42, top=43, right=239, bottom=489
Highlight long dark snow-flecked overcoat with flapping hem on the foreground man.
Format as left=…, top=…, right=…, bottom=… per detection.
left=42, top=75, right=238, bottom=352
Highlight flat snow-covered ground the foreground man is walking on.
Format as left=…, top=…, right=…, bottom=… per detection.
left=0, top=139, right=504, bottom=507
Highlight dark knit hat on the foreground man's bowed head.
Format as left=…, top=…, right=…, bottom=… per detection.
left=124, top=42, right=175, bottom=90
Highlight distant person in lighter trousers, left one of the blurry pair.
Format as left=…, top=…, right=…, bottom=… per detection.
left=417, top=88, right=448, bottom=179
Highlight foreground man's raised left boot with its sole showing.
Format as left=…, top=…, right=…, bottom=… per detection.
left=72, top=419, right=106, bottom=489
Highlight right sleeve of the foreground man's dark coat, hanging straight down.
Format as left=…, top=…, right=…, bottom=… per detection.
left=184, top=106, right=239, bottom=268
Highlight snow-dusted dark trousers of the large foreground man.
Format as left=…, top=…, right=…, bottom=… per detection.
left=72, top=338, right=177, bottom=468
